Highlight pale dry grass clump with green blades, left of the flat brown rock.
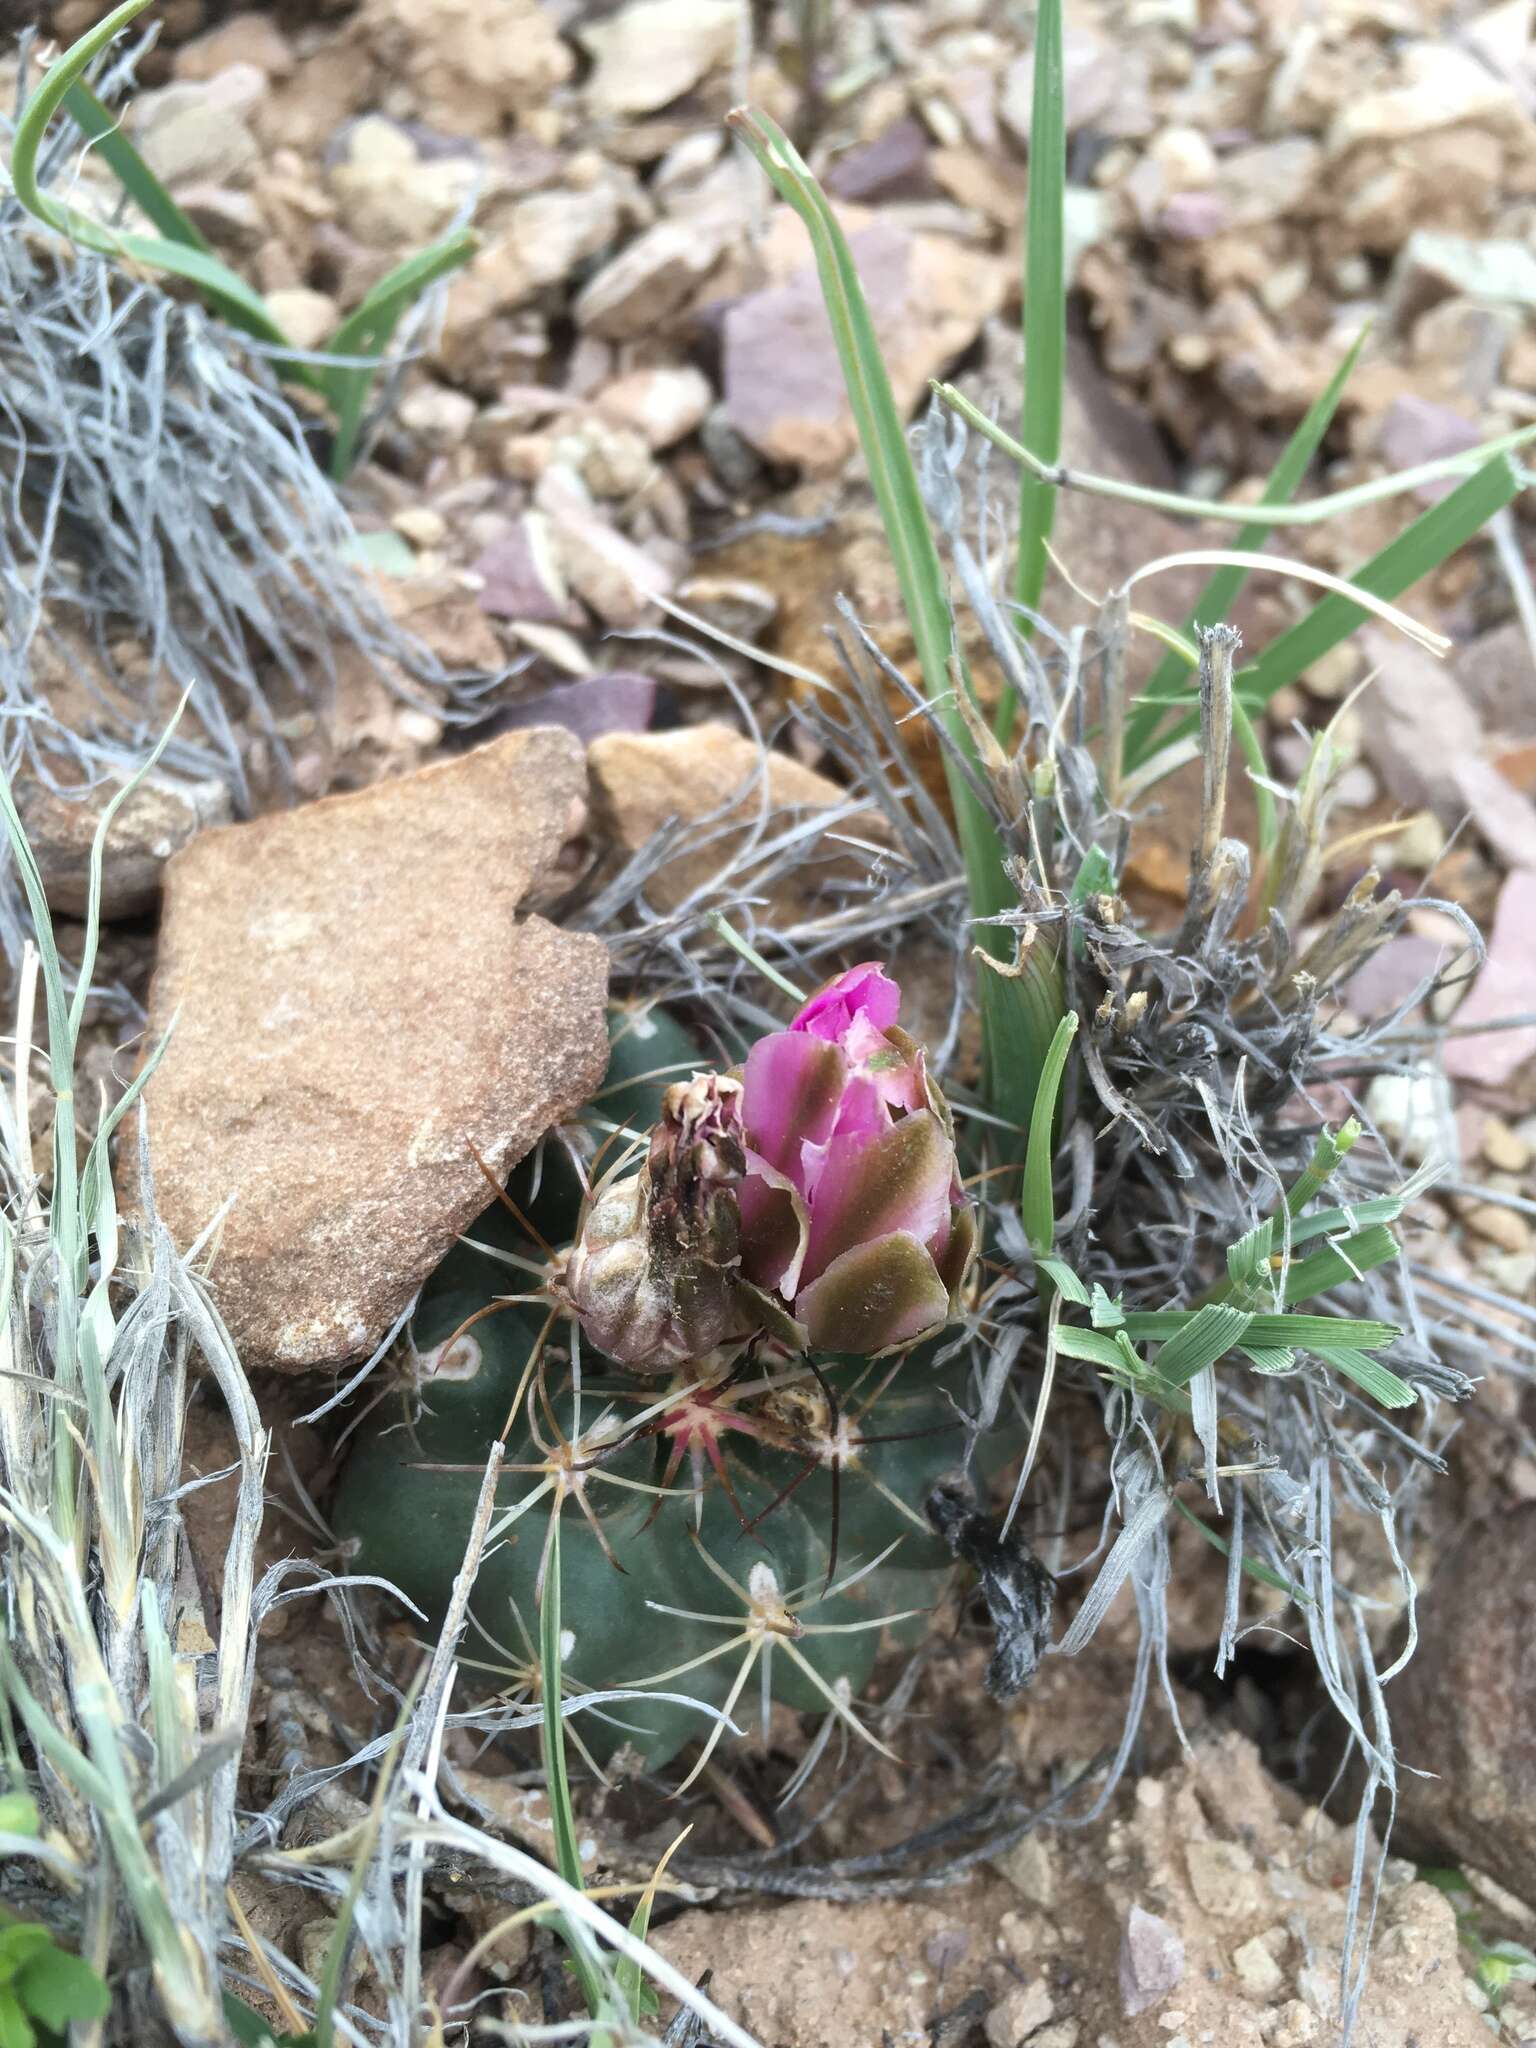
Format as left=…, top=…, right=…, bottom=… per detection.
left=0, top=720, right=266, bottom=2042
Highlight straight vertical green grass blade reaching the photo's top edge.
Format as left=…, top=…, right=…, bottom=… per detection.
left=1015, top=0, right=1067, bottom=647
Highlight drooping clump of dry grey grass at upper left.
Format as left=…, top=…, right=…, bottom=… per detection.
left=0, top=22, right=507, bottom=888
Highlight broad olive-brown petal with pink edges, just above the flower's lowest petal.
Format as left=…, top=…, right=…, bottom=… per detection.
left=803, top=1110, right=954, bottom=1280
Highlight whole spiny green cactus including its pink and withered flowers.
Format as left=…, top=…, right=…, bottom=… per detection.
left=334, top=971, right=1016, bottom=1772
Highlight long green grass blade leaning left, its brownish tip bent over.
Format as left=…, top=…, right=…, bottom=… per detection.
left=731, top=111, right=1061, bottom=1130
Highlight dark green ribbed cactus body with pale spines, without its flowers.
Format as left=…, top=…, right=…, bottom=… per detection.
left=334, top=1012, right=1012, bottom=1767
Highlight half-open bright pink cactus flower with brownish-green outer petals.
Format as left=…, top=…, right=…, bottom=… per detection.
left=737, top=963, right=975, bottom=1354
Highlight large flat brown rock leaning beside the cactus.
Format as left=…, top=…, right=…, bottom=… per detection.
left=145, top=727, right=608, bottom=1372
